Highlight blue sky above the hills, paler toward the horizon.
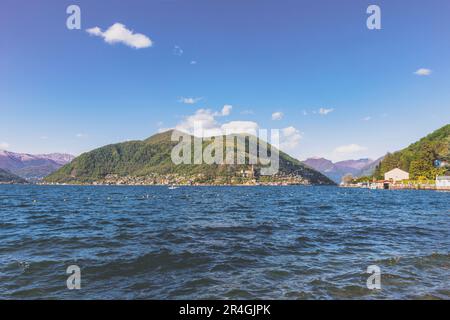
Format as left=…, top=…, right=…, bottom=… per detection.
left=0, top=0, right=450, bottom=160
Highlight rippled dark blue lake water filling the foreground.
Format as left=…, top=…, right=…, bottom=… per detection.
left=0, top=185, right=450, bottom=299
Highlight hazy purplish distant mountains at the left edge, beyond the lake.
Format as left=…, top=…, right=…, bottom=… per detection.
left=0, top=150, right=75, bottom=181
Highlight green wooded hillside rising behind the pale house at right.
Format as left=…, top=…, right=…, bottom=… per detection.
left=374, top=124, right=450, bottom=180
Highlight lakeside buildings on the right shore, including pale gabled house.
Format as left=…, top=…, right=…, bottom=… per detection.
left=340, top=162, right=450, bottom=191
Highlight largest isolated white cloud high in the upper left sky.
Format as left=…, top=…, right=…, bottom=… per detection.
left=86, top=23, right=153, bottom=49
